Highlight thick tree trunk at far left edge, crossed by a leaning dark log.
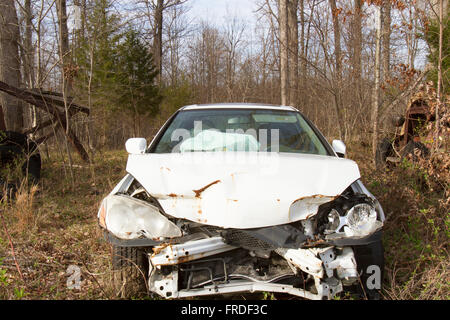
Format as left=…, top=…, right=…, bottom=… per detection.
left=0, top=0, right=23, bottom=131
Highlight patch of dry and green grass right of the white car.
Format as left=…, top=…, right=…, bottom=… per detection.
left=350, top=142, right=450, bottom=300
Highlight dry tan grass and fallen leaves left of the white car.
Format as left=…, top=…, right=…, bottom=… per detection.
left=0, top=152, right=130, bottom=299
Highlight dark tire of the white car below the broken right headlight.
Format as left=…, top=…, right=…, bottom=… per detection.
left=353, top=240, right=384, bottom=300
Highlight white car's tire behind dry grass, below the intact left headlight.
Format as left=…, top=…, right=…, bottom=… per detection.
left=112, top=245, right=148, bottom=299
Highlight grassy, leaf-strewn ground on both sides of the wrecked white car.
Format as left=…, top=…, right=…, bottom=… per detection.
left=0, top=144, right=450, bottom=299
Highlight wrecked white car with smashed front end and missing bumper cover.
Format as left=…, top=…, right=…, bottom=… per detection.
left=98, top=104, right=385, bottom=299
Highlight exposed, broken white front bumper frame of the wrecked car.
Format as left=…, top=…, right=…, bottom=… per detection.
left=148, top=237, right=376, bottom=300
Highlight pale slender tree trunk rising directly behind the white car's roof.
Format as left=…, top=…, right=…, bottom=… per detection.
left=278, top=0, right=289, bottom=105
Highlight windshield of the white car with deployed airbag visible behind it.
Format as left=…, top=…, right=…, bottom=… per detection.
left=152, top=109, right=328, bottom=155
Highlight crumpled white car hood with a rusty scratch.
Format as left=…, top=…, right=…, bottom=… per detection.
left=127, top=152, right=360, bottom=229
